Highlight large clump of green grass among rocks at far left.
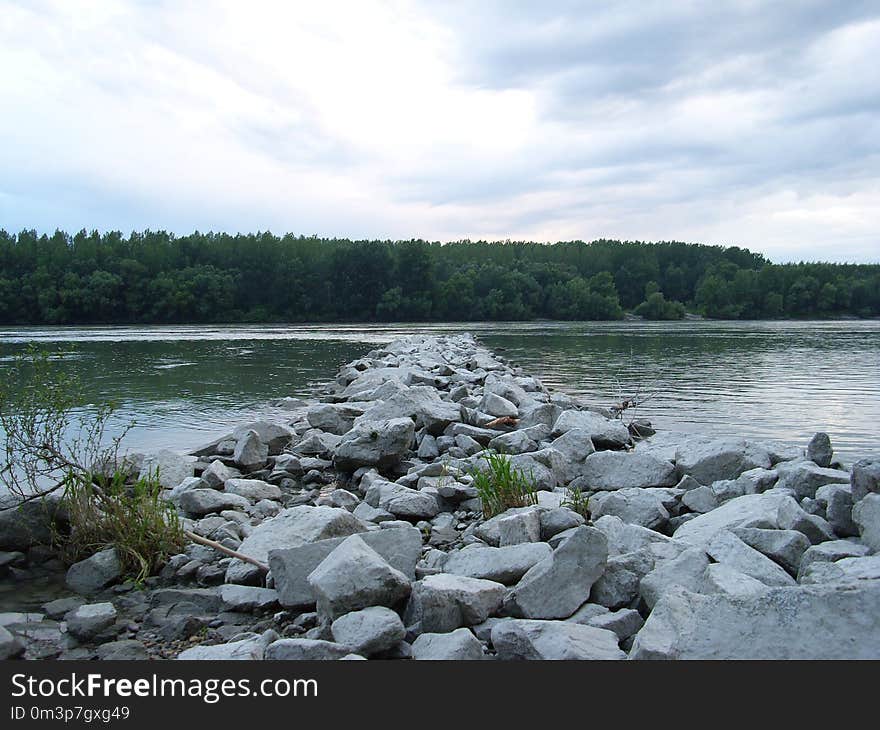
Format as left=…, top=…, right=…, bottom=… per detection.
left=59, top=470, right=186, bottom=583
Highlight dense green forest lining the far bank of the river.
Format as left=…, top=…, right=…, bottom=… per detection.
left=0, top=230, right=880, bottom=325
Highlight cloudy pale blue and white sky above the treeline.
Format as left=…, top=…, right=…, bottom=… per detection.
left=0, top=0, right=880, bottom=262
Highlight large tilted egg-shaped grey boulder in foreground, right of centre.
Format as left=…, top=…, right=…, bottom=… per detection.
left=505, top=526, right=608, bottom=619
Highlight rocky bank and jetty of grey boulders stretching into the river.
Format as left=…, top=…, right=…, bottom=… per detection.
left=0, top=335, right=880, bottom=659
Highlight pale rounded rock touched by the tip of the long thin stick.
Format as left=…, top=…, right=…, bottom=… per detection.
left=226, top=505, right=366, bottom=583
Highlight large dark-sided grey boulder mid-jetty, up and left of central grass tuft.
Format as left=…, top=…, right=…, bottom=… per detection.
left=333, top=418, right=415, bottom=472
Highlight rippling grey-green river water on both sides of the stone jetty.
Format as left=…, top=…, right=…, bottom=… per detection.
left=0, top=321, right=880, bottom=462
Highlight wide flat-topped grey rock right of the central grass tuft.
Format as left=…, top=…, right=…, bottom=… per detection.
left=572, top=451, right=678, bottom=491
